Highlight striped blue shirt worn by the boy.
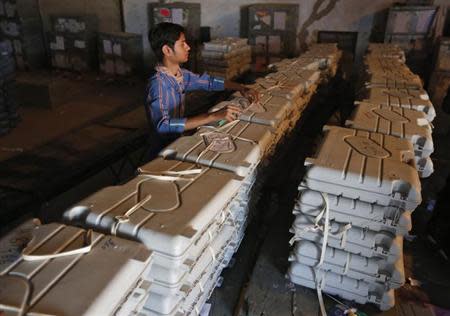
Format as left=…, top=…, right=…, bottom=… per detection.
left=145, top=67, right=224, bottom=136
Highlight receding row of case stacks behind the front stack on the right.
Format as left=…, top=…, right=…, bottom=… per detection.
left=356, top=44, right=436, bottom=177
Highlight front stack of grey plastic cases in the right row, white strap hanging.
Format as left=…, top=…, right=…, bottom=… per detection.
left=288, top=127, right=421, bottom=310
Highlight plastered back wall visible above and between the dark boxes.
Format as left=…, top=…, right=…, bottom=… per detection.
left=36, top=0, right=448, bottom=66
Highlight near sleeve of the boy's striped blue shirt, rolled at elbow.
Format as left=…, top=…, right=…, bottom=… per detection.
left=146, top=74, right=186, bottom=134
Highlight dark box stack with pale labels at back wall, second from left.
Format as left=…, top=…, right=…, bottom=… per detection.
left=48, top=15, right=98, bottom=72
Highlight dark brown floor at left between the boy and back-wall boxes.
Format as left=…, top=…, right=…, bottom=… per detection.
left=0, top=75, right=145, bottom=161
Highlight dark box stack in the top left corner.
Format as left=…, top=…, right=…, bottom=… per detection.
left=0, top=0, right=46, bottom=70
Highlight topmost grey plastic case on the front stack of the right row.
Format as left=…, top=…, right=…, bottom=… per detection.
left=300, top=126, right=422, bottom=210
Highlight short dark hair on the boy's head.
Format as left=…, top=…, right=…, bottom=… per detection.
left=148, top=22, right=185, bottom=62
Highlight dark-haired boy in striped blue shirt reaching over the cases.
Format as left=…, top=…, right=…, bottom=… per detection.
left=145, top=23, right=258, bottom=140
